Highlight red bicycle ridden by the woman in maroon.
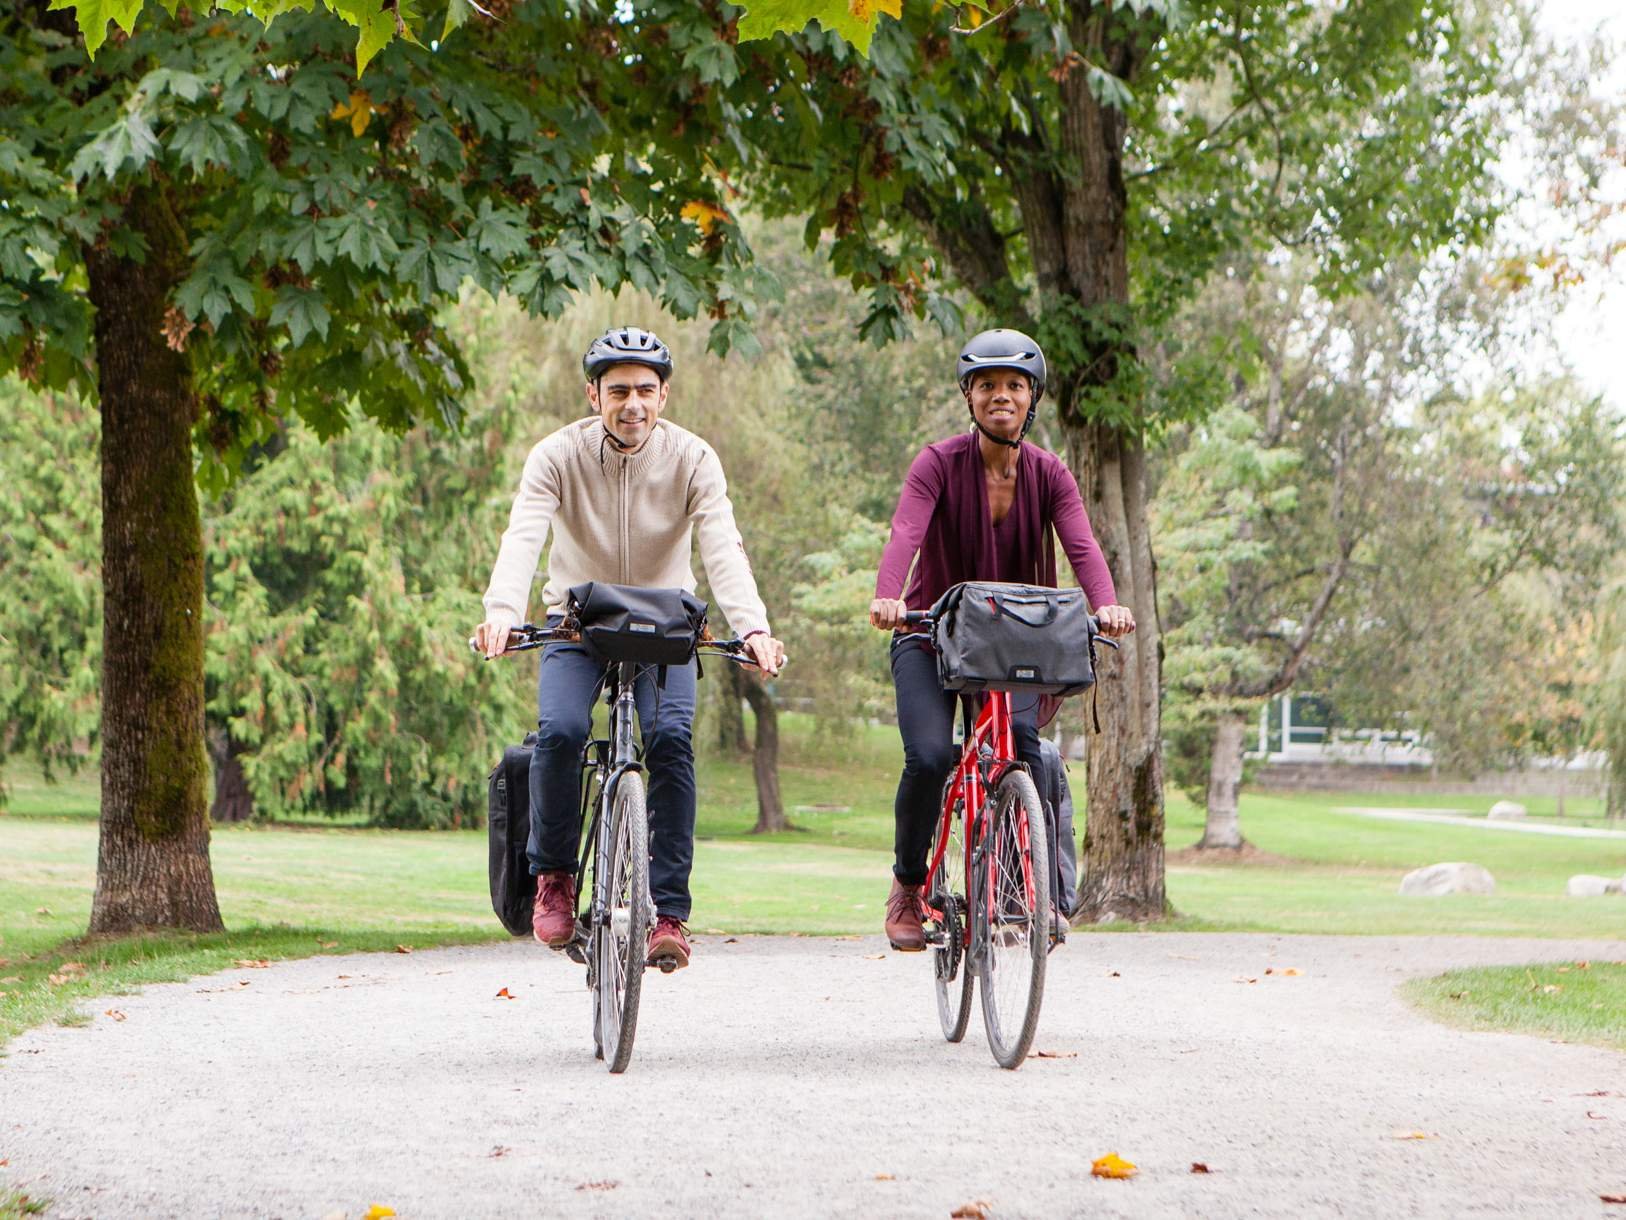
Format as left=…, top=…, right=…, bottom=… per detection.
left=906, top=612, right=1111, bottom=1069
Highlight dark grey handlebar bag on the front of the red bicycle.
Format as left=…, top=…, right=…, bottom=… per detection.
left=932, top=581, right=1096, bottom=695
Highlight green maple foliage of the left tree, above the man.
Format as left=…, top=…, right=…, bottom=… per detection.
left=0, top=2, right=764, bottom=468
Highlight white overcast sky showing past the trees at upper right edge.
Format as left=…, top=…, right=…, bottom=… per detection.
left=1541, top=0, right=1626, bottom=410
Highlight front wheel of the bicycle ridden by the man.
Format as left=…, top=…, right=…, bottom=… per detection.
left=593, top=771, right=654, bottom=1072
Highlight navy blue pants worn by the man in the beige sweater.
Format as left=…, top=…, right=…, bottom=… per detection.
left=527, top=631, right=694, bottom=919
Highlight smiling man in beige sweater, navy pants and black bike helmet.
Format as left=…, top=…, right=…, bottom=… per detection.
left=475, top=327, right=785, bottom=966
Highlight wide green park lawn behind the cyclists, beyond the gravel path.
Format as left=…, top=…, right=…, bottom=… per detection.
left=0, top=735, right=1626, bottom=1041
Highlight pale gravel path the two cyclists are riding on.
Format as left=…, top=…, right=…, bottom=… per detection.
left=0, top=934, right=1626, bottom=1220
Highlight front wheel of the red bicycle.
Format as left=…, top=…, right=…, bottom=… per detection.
left=971, top=771, right=1050, bottom=1067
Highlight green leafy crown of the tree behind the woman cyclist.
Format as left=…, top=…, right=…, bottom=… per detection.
left=725, top=0, right=1504, bottom=431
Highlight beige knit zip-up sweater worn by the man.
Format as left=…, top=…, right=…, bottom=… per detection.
left=485, top=416, right=769, bottom=636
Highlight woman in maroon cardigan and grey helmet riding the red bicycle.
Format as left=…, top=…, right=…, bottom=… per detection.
left=870, top=329, right=1135, bottom=953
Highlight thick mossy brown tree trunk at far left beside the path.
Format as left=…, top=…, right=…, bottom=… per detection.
left=86, top=182, right=223, bottom=934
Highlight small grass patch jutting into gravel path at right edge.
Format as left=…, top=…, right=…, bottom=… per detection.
left=1403, top=961, right=1626, bottom=1051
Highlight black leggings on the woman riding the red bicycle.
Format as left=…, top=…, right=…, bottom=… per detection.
left=893, top=636, right=1044, bottom=885
